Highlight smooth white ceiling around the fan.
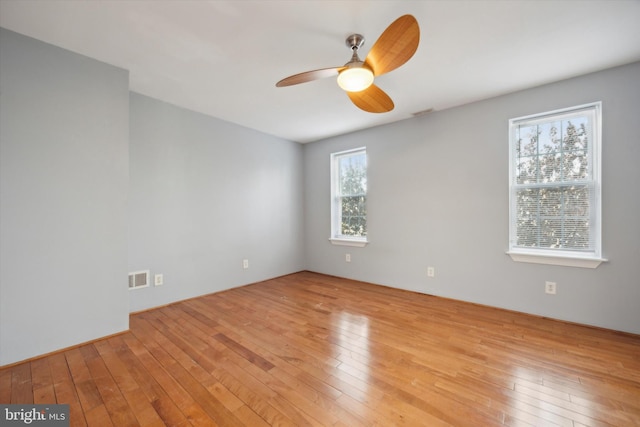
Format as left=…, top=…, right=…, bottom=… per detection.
left=0, top=0, right=640, bottom=142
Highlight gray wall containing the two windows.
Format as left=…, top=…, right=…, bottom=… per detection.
left=304, top=63, right=640, bottom=333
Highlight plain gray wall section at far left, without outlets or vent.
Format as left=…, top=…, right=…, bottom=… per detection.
left=0, top=29, right=129, bottom=365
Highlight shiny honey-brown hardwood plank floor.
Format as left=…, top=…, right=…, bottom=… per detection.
left=0, top=272, right=640, bottom=427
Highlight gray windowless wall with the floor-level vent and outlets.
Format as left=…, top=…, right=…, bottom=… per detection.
left=129, top=93, right=304, bottom=311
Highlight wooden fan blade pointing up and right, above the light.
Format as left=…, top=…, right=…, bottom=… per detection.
left=364, top=15, right=420, bottom=76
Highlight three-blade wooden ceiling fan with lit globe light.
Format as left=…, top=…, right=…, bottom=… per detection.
left=276, top=15, right=420, bottom=113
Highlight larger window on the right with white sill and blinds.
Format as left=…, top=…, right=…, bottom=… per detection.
left=509, top=103, right=605, bottom=268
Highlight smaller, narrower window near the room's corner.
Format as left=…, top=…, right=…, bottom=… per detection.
left=330, top=147, right=367, bottom=246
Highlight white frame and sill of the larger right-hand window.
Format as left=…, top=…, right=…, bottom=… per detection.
left=507, top=102, right=607, bottom=268
